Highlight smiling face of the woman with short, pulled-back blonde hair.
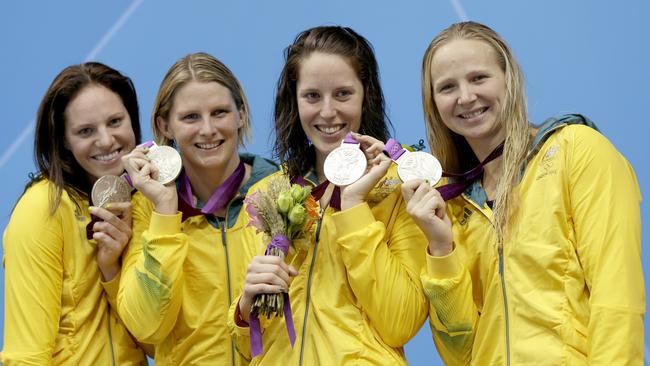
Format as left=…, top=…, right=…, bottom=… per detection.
left=156, top=81, right=244, bottom=174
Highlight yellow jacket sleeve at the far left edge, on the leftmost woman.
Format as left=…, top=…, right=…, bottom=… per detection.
left=2, top=187, right=63, bottom=366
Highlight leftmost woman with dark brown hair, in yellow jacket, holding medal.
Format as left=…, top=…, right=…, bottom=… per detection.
left=2, top=62, right=146, bottom=365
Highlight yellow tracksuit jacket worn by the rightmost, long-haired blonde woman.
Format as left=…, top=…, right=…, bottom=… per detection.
left=422, top=116, right=645, bottom=366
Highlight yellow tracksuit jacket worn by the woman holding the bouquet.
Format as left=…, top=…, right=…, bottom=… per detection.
left=228, top=166, right=427, bottom=366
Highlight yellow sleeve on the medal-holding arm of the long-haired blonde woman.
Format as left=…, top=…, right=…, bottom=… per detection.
left=421, top=248, right=479, bottom=365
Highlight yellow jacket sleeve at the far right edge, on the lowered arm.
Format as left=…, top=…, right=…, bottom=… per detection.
left=567, top=127, right=645, bottom=365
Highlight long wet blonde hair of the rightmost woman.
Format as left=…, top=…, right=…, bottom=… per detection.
left=422, top=22, right=530, bottom=243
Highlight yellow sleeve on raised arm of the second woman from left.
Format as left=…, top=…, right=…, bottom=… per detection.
left=117, top=197, right=188, bottom=344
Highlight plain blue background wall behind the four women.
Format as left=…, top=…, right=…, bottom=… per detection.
left=0, top=0, right=650, bottom=365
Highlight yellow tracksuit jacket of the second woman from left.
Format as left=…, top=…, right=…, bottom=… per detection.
left=117, top=154, right=277, bottom=366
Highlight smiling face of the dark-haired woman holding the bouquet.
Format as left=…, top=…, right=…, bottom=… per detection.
left=296, top=52, right=364, bottom=167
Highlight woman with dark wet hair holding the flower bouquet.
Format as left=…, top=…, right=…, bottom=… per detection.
left=228, top=27, right=427, bottom=365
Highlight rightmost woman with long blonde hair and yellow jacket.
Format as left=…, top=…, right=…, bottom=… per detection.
left=403, top=22, right=645, bottom=365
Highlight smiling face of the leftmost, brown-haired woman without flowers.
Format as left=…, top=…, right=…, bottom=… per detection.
left=64, top=84, right=135, bottom=183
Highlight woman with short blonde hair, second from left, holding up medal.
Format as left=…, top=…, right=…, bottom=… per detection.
left=118, top=53, right=277, bottom=365
